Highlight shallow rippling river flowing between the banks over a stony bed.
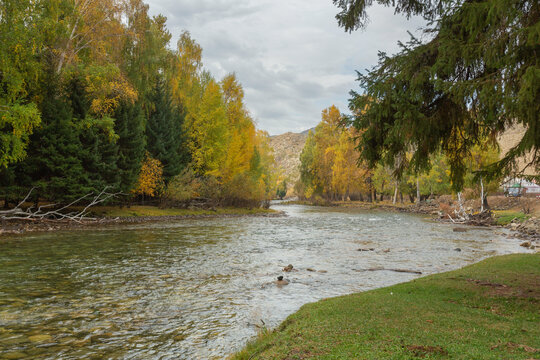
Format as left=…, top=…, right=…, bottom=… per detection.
left=0, top=205, right=526, bottom=359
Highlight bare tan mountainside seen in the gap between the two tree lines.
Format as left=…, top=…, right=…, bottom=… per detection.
left=270, top=129, right=311, bottom=194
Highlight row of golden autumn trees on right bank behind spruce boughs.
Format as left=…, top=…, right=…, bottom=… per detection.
left=295, top=106, right=500, bottom=203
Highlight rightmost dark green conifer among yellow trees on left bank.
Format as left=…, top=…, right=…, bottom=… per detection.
left=146, top=81, right=188, bottom=181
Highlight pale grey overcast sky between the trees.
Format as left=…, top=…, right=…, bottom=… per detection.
left=148, top=0, right=423, bottom=135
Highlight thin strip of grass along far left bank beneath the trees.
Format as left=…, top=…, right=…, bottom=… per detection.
left=86, top=206, right=276, bottom=217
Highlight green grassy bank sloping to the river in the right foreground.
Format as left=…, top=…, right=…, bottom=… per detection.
left=232, top=254, right=540, bottom=359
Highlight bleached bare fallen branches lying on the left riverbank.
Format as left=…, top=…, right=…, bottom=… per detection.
left=0, top=187, right=120, bottom=222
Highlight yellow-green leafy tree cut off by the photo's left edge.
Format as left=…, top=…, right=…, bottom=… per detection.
left=0, top=0, right=42, bottom=168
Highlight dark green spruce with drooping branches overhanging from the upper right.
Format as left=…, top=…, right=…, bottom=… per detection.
left=334, top=0, right=540, bottom=191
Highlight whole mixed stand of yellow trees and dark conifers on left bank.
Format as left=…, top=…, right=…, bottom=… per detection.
left=0, top=0, right=276, bottom=215
